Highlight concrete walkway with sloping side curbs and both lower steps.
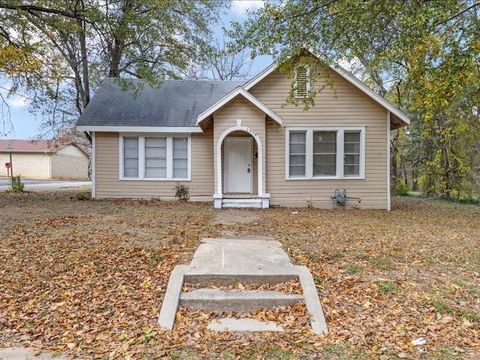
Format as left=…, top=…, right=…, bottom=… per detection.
left=159, top=239, right=327, bottom=334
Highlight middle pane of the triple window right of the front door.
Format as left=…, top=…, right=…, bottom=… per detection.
left=313, top=131, right=337, bottom=176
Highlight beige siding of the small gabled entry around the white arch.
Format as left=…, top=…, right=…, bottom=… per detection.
left=213, top=96, right=265, bottom=193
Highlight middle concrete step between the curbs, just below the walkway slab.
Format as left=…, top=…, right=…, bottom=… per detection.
left=180, top=289, right=303, bottom=311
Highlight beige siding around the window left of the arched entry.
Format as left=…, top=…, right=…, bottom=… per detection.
left=95, top=126, right=214, bottom=201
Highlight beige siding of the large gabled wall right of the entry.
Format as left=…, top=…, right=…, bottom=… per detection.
left=250, top=70, right=387, bottom=209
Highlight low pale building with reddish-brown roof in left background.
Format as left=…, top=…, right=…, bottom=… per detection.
left=0, top=140, right=89, bottom=180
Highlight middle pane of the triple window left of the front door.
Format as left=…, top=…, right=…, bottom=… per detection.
left=145, top=138, right=167, bottom=179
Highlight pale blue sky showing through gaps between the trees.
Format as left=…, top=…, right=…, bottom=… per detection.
left=0, top=0, right=272, bottom=139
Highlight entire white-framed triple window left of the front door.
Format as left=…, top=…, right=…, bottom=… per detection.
left=120, top=135, right=191, bottom=181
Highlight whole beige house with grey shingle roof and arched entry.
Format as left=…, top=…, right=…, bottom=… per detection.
left=78, top=54, right=410, bottom=209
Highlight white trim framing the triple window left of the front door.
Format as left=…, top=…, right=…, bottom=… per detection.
left=118, top=133, right=192, bottom=182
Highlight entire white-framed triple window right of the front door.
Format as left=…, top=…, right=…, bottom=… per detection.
left=286, top=127, right=365, bottom=179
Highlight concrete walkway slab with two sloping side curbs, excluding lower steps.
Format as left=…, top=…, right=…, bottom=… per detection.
left=158, top=239, right=328, bottom=335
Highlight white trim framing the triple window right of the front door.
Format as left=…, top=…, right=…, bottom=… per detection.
left=285, top=126, right=366, bottom=181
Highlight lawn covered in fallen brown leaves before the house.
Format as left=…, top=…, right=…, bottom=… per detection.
left=0, top=192, right=480, bottom=359
